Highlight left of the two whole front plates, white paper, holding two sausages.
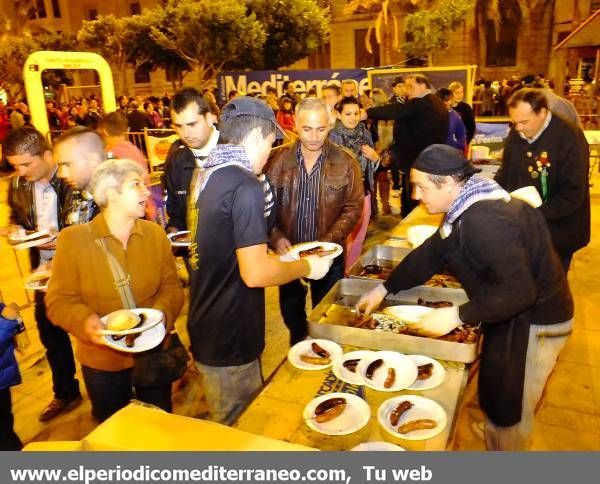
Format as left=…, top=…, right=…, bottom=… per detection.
left=302, top=393, right=371, bottom=435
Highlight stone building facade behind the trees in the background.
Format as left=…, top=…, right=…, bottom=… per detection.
left=0, top=0, right=600, bottom=98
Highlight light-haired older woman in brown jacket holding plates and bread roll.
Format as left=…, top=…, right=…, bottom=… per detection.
left=46, top=160, right=183, bottom=421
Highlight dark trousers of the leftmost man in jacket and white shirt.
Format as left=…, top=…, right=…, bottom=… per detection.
left=35, top=291, right=79, bottom=400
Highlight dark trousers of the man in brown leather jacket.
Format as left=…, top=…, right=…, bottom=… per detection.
left=279, top=256, right=344, bottom=346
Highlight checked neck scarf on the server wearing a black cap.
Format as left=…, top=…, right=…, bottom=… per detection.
left=440, top=175, right=510, bottom=239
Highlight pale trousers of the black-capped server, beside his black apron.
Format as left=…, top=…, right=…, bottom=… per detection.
left=485, top=319, right=573, bottom=451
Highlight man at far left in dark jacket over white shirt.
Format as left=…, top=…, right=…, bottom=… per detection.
left=3, top=127, right=81, bottom=422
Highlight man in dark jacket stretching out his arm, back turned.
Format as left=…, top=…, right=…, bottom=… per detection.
left=367, top=74, right=448, bottom=217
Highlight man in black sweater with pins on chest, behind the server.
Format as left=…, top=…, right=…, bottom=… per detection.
left=496, top=89, right=590, bottom=272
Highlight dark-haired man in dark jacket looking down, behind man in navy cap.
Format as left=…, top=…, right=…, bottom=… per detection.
left=163, top=87, right=219, bottom=233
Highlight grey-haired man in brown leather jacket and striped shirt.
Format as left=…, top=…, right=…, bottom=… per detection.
left=267, top=98, right=364, bottom=345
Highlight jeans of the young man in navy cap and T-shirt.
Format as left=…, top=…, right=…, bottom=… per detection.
left=196, top=359, right=263, bottom=425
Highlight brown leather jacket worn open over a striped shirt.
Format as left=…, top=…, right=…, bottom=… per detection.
left=267, top=141, right=365, bottom=248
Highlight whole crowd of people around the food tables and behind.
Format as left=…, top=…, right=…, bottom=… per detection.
left=0, top=67, right=590, bottom=450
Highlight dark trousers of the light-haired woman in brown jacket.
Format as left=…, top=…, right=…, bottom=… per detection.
left=81, top=365, right=171, bottom=422
